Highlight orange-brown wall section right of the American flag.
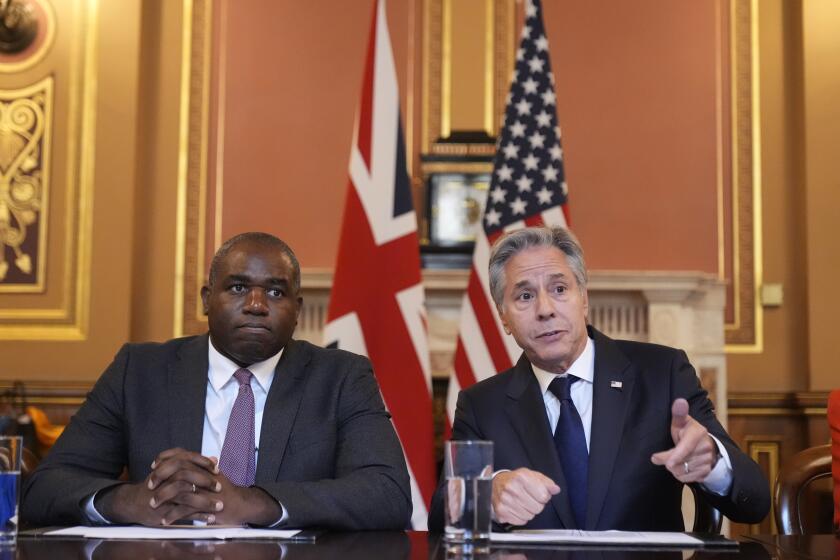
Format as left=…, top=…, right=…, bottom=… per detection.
left=544, top=0, right=718, bottom=272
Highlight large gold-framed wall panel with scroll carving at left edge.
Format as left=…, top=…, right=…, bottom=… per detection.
left=0, top=0, right=98, bottom=340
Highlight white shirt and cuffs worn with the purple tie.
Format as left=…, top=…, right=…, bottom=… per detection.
left=85, top=339, right=288, bottom=525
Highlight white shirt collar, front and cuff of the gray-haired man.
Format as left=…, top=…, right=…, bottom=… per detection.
left=531, top=338, right=732, bottom=496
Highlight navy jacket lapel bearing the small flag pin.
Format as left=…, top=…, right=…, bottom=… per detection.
left=585, top=327, right=636, bottom=529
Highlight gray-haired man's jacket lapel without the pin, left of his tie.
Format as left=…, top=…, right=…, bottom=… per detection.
left=505, top=355, right=575, bottom=528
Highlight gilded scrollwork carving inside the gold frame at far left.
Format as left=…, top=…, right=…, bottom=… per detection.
left=0, top=77, right=53, bottom=284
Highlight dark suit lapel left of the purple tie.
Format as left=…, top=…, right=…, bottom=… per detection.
left=167, top=335, right=209, bottom=453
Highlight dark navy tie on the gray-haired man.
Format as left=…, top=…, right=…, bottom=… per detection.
left=548, top=375, right=589, bottom=529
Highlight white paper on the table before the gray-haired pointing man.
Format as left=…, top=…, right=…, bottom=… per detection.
left=490, top=529, right=703, bottom=547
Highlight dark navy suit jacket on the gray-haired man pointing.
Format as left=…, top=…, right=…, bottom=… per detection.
left=429, top=327, right=770, bottom=531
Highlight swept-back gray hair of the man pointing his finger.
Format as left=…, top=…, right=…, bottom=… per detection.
left=490, top=226, right=587, bottom=308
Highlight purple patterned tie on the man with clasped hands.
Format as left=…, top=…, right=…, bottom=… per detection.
left=219, top=369, right=257, bottom=486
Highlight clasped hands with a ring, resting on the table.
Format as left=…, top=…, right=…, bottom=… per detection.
left=95, top=448, right=281, bottom=526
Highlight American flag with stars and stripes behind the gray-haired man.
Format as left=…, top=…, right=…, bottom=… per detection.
left=447, top=0, right=568, bottom=419
